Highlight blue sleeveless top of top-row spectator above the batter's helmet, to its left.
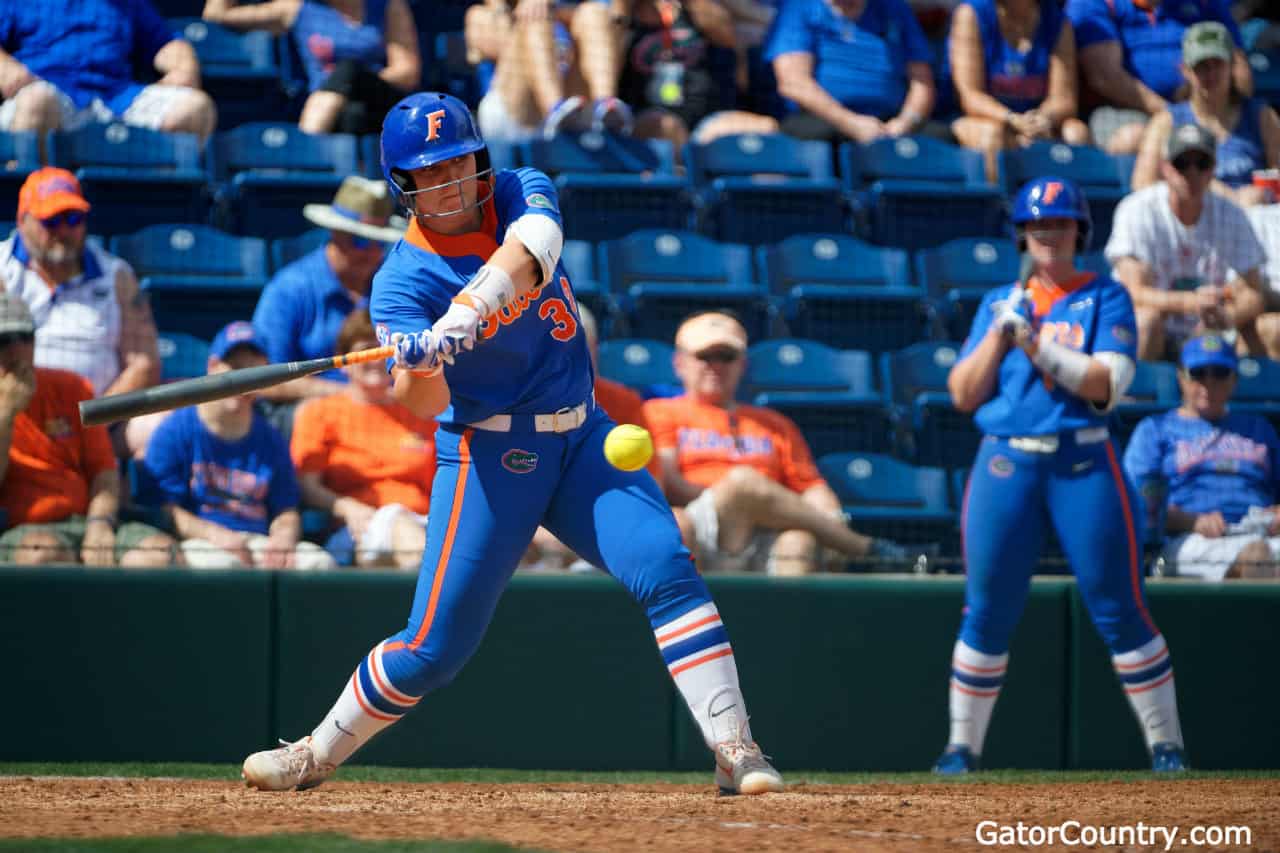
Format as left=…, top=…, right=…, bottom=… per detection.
left=289, top=0, right=387, bottom=92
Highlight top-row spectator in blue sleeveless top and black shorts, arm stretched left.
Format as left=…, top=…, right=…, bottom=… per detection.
left=204, top=0, right=422, bottom=133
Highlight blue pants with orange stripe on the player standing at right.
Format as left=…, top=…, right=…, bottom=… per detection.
left=960, top=434, right=1157, bottom=654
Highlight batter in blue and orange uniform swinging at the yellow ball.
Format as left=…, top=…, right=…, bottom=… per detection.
left=243, top=92, right=782, bottom=794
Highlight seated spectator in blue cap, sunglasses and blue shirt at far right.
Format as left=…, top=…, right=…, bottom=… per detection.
left=1124, top=334, right=1280, bottom=580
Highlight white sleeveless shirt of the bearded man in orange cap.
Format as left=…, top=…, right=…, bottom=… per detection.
left=0, top=231, right=128, bottom=394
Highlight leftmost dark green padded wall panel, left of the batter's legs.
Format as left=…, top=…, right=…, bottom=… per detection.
left=0, top=569, right=273, bottom=761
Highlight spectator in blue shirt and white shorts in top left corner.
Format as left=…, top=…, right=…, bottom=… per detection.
left=0, top=0, right=218, bottom=140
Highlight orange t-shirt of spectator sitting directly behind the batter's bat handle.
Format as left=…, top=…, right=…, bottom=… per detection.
left=289, top=393, right=435, bottom=512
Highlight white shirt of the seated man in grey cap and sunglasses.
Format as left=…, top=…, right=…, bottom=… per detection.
left=1106, top=182, right=1266, bottom=336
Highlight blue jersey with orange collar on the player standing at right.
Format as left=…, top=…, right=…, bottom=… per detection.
left=960, top=273, right=1138, bottom=435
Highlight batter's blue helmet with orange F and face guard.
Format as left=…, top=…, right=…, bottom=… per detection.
left=381, top=92, right=493, bottom=216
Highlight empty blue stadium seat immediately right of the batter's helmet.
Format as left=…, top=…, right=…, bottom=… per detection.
left=517, top=133, right=694, bottom=241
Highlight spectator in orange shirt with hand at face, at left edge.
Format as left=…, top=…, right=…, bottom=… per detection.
left=0, top=293, right=180, bottom=569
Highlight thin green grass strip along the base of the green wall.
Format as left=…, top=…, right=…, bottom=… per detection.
left=0, top=762, right=1280, bottom=788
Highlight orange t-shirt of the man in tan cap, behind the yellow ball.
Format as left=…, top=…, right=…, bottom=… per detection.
left=644, top=396, right=823, bottom=493
